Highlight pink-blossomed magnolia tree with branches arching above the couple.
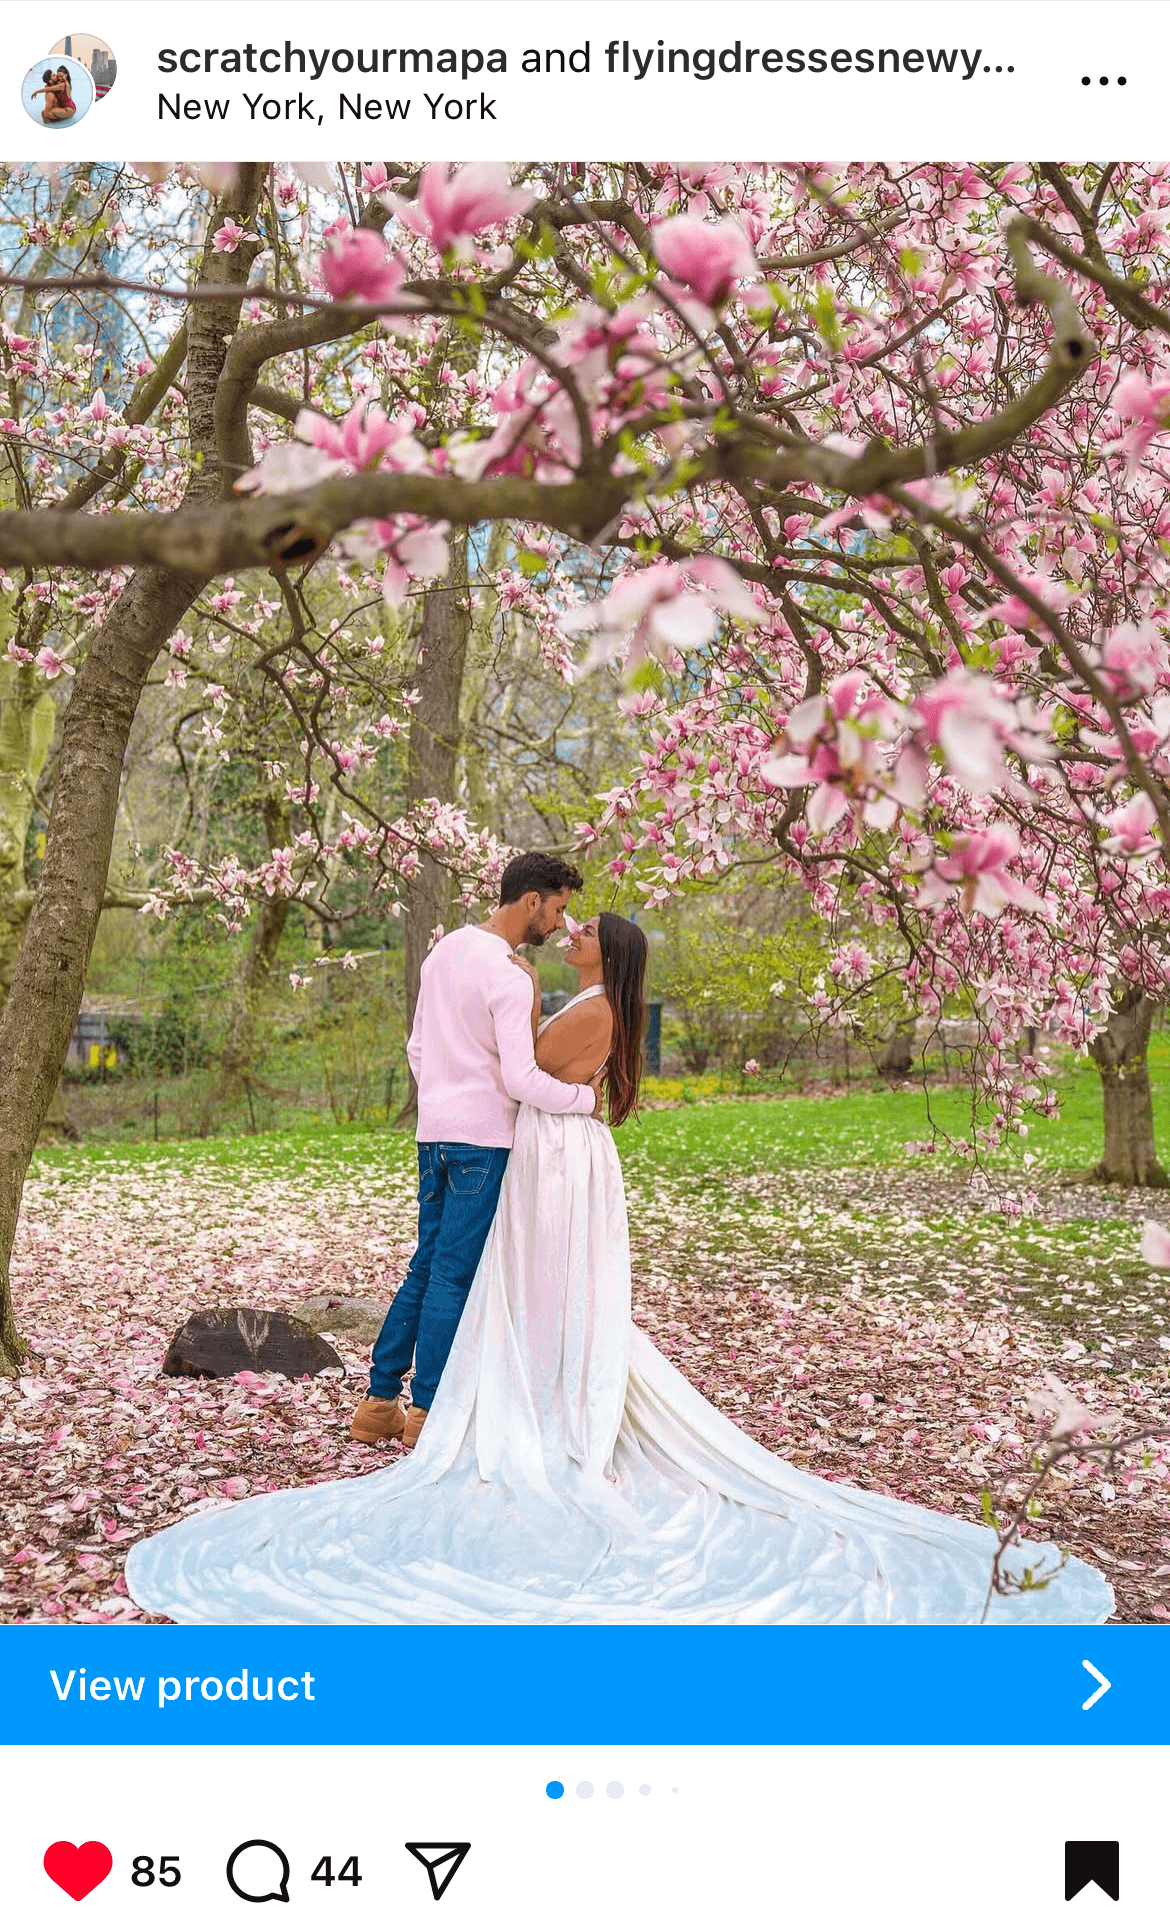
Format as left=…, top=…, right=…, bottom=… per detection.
left=0, top=162, right=1170, bottom=1367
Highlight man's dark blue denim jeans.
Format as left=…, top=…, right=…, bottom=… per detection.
left=369, top=1139, right=510, bottom=1408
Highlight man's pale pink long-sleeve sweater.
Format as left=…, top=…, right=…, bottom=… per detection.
left=405, top=925, right=595, bottom=1147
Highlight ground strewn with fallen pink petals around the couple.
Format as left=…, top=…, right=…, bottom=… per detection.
left=0, top=1108, right=1170, bottom=1622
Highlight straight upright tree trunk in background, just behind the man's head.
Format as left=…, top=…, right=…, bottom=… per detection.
left=394, top=533, right=471, bottom=1126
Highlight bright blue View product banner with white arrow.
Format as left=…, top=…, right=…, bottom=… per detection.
left=0, top=1626, right=1170, bottom=1746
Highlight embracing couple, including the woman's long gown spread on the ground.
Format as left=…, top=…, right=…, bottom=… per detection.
left=125, top=854, right=1112, bottom=1624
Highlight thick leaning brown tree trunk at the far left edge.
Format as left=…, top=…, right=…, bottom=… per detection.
left=0, top=162, right=265, bottom=1375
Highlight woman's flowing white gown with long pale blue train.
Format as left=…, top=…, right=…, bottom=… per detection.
left=125, top=987, right=1112, bottom=1624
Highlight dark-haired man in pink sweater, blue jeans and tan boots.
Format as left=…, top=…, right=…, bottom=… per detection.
left=349, top=852, right=600, bottom=1448
